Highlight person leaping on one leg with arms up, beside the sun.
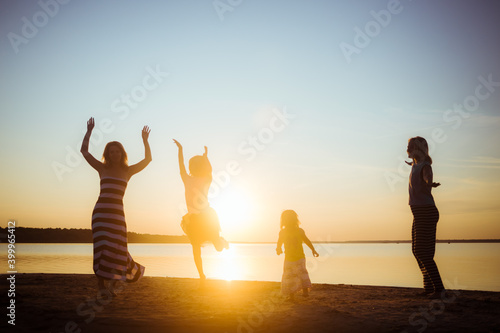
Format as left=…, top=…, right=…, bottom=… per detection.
left=174, top=139, right=229, bottom=283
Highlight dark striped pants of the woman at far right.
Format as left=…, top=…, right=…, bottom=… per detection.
left=411, top=206, right=444, bottom=293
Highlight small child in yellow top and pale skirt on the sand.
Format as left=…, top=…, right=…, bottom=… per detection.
left=276, top=210, right=319, bottom=300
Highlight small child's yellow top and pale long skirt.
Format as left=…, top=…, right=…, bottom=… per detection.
left=280, top=228, right=311, bottom=295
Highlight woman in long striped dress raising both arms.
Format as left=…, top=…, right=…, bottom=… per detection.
left=80, top=118, right=151, bottom=295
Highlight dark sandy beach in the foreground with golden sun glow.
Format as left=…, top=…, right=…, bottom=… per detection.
left=0, top=274, right=500, bottom=333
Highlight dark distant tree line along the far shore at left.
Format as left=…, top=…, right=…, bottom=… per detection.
left=0, top=227, right=189, bottom=243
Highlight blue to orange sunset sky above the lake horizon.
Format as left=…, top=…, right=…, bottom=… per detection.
left=0, top=0, right=500, bottom=242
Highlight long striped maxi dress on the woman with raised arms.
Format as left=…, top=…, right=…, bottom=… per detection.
left=92, top=177, right=145, bottom=282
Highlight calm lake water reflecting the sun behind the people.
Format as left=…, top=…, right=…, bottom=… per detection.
left=0, top=243, right=500, bottom=291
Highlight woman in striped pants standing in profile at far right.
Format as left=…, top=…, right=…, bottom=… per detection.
left=407, top=136, right=444, bottom=296
